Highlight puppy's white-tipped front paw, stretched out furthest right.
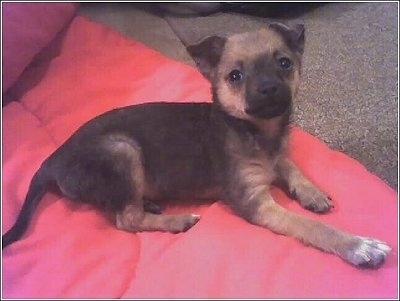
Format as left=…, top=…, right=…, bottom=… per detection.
left=342, top=236, right=391, bottom=268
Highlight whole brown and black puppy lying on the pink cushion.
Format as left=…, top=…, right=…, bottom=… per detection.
left=2, top=23, right=390, bottom=267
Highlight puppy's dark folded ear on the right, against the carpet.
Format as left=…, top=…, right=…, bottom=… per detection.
left=268, top=22, right=305, bottom=54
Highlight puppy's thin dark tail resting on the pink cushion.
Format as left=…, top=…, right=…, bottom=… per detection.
left=1, top=168, right=50, bottom=249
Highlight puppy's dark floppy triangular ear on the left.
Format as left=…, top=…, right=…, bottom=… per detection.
left=186, top=36, right=226, bottom=81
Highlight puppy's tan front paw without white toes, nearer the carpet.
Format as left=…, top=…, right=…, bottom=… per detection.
left=292, top=185, right=334, bottom=213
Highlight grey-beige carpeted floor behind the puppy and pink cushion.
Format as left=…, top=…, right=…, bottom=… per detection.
left=80, top=2, right=398, bottom=189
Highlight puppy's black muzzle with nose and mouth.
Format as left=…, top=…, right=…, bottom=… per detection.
left=245, top=81, right=292, bottom=119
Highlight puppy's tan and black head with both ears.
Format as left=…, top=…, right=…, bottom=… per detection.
left=187, top=23, right=304, bottom=120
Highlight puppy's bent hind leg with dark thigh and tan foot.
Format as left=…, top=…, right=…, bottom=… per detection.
left=57, top=134, right=200, bottom=232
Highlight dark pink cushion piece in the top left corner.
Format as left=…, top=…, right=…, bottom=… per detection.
left=2, top=2, right=77, bottom=92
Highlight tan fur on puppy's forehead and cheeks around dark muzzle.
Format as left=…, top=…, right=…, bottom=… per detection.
left=215, top=28, right=300, bottom=121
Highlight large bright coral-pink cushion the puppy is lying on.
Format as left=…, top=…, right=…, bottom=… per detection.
left=2, top=17, right=398, bottom=299
